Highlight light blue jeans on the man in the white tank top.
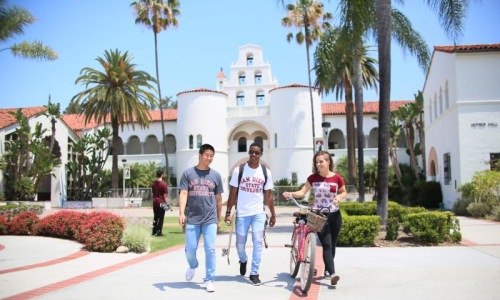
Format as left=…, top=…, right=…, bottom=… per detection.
left=236, top=213, right=266, bottom=275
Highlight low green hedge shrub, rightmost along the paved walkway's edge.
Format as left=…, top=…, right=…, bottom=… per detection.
left=403, top=211, right=462, bottom=243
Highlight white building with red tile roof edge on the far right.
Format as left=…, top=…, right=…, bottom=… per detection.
left=422, top=44, right=500, bottom=209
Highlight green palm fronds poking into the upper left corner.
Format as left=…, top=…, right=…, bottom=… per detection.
left=0, top=0, right=57, bottom=60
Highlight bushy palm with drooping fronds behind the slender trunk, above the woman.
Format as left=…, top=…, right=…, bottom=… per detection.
left=314, top=28, right=378, bottom=192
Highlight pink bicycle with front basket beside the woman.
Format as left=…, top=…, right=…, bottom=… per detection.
left=285, top=198, right=326, bottom=293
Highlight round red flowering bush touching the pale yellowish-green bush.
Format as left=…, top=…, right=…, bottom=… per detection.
left=81, top=212, right=125, bottom=252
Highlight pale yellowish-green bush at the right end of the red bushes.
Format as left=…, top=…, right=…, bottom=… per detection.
left=122, top=218, right=151, bottom=253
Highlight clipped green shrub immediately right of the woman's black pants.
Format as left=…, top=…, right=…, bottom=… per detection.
left=337, top=215, right=380, bottom=247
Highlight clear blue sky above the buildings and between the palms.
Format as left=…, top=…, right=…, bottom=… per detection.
left=0, top=0, right=500, bottom=110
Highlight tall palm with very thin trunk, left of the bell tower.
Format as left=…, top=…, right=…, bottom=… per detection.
left=131, top=0, right=180, bottom=184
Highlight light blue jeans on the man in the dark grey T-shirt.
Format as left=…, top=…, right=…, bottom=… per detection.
left=185, top=223, right=217, bottom=281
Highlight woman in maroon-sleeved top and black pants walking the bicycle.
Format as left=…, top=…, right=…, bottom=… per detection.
left=283, top=151, right=347, bottom=285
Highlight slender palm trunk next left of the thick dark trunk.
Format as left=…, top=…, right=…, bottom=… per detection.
left=353, top=50, right=365, bottom=203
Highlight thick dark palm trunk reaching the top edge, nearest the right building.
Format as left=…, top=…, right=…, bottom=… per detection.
left=376, top=0, right=391, bottom=225
